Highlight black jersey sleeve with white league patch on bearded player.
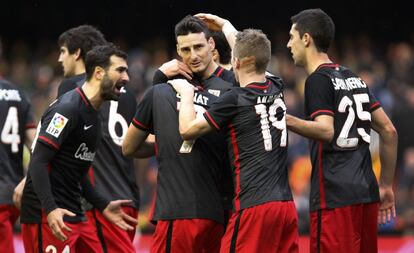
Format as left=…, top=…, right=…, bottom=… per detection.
left=38, top=104, right=78, bottom=150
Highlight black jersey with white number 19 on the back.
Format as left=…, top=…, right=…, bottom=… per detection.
left=204, top=77, right=292, bottom=211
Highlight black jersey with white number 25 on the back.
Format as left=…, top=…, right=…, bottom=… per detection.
left=305, top=64, right=380, bottom=211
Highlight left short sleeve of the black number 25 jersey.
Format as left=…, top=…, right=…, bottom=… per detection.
left=305, top=74, right=335, bottom=120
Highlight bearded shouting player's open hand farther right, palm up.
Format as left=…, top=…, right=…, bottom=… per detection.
left=102, top=200, right=138, bottom=230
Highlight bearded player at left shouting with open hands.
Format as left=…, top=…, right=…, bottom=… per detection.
left=21, top=44, right=137, bottom=253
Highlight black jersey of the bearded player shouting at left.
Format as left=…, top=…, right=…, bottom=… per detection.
left=21, top=88, right=102, bottom=223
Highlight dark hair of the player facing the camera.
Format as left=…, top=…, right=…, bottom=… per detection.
left=175, top=15, right=211, bottom=39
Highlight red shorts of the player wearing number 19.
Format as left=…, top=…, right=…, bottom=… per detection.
left=220, top=201, right=299, bottom=253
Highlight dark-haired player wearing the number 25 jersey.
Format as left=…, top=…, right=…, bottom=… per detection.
left=287, top=9, right=397, bottom=253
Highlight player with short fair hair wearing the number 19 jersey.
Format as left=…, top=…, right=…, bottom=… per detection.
left=170, top=29, right=298, bottom=253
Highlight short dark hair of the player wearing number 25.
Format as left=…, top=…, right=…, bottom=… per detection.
left=290, top=9, right=335, bottom=53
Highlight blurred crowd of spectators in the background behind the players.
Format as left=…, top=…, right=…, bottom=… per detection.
left=0, top=28, right=414, bottom=234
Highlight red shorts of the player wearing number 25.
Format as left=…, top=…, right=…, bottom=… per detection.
left=310, top=203, right=379, bottom=253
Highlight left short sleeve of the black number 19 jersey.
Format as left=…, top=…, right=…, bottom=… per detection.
left=204, top=90, right=237, bottom=130
